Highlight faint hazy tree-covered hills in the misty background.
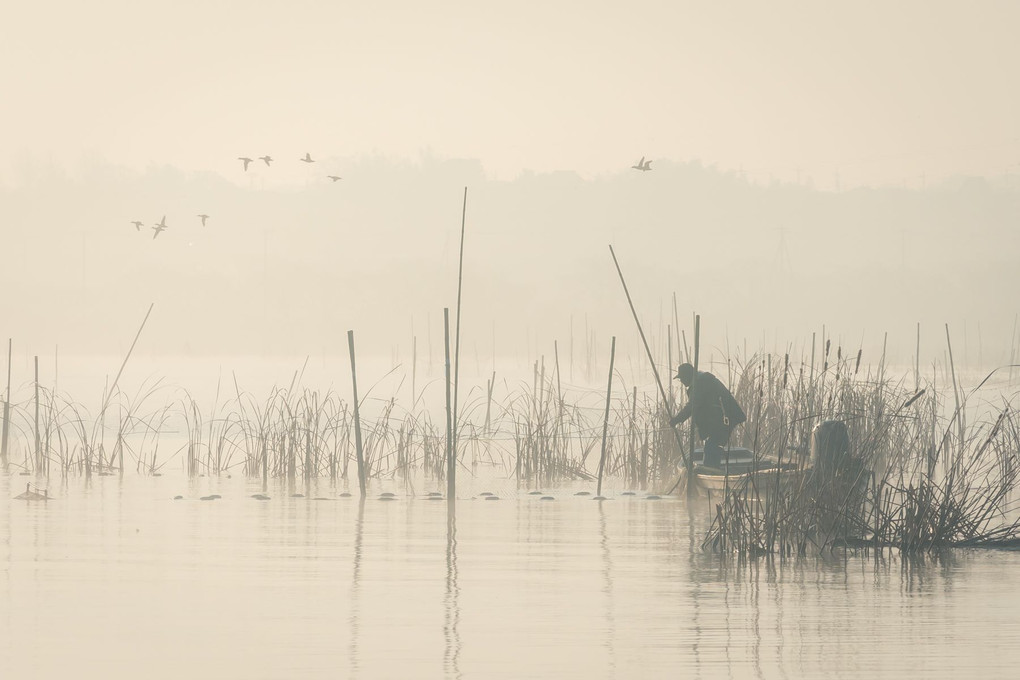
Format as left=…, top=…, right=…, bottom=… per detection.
left=0, top=155, right=1020, bottom=364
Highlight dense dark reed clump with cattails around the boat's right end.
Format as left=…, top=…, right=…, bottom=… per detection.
left=703, top=353, right=1020, bottom=557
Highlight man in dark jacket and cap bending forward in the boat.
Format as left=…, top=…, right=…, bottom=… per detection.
left=669, top=364, right=748, bottom=468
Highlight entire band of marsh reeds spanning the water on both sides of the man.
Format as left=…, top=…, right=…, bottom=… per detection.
left=3, top=346, right=1020, bottom=557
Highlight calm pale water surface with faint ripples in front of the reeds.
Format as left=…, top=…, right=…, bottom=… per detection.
left=0, top=475, right=1020, bottom=679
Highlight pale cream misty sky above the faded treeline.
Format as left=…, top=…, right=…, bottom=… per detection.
left=0, top=0, right=1020, bottom=189
